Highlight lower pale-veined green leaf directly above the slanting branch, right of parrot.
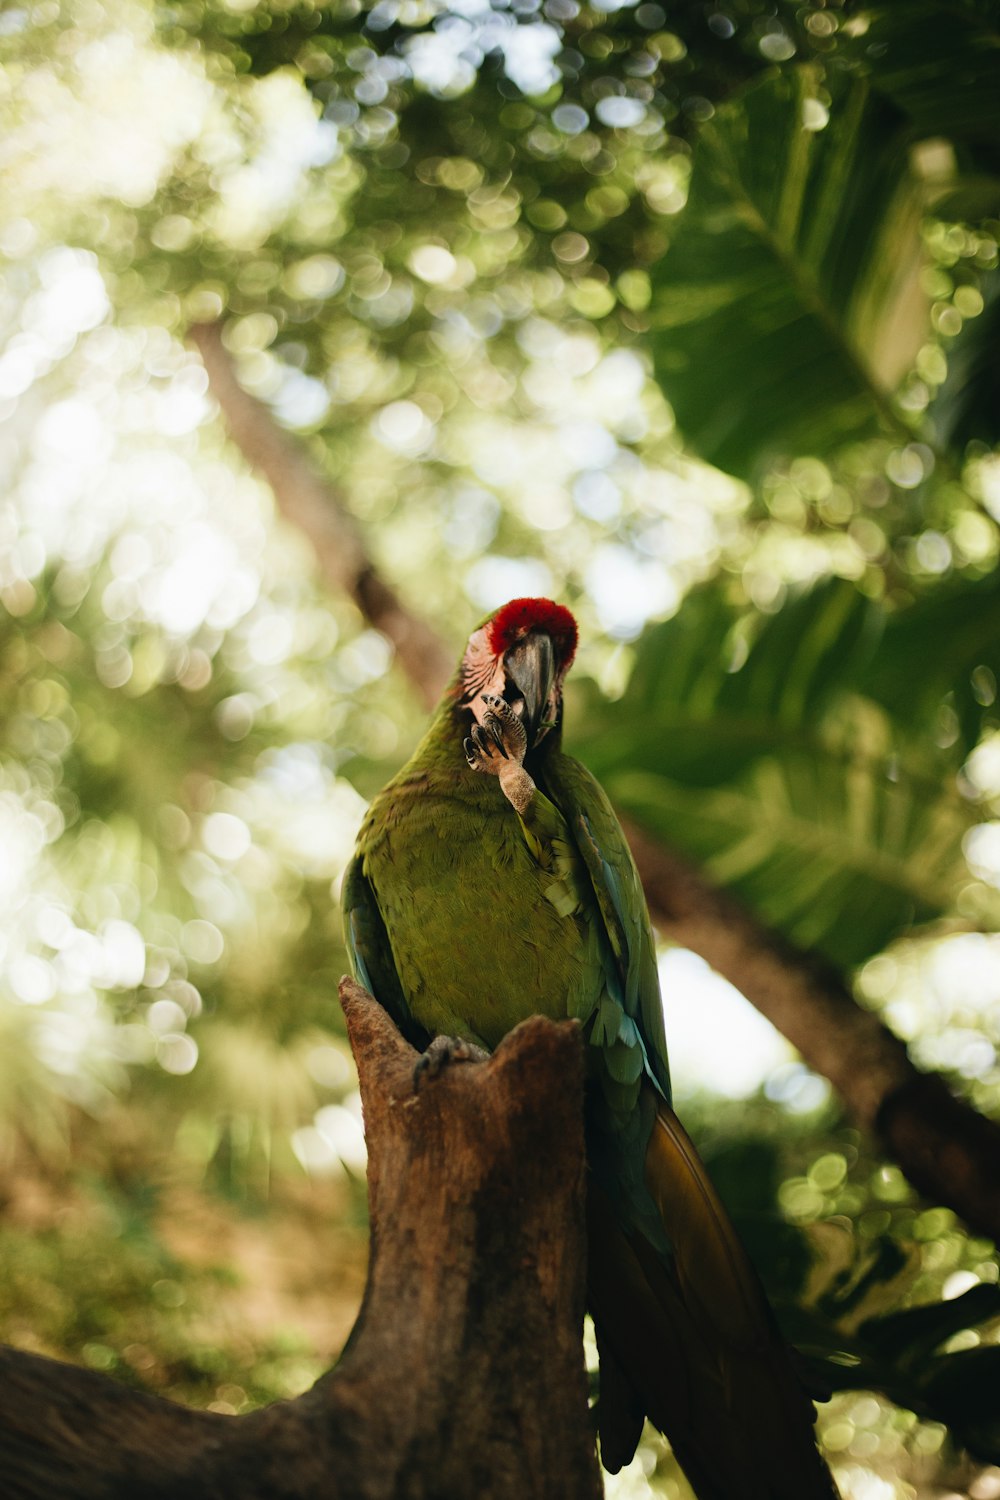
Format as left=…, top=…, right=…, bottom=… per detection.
left=604, top=731, right=996, bottom=966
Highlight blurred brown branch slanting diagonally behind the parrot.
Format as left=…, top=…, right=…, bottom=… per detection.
left=193, top=326, right=1000, bottom=1241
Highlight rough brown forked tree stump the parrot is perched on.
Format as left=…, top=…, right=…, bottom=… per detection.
left=0, top=980, right=601, bottom=1500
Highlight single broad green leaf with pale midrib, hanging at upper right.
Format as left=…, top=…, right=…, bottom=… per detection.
left=651, top=66, right=925, bottom=477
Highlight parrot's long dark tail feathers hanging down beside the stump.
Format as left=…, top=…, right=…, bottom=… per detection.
left=588, top=1100, right=837, bottom=1500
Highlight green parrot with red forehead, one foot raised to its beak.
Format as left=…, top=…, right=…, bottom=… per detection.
left=343, top=599, right=837, bottom=1500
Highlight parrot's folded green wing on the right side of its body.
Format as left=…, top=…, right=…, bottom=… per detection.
left=544, top=753, right=670, bottom=1100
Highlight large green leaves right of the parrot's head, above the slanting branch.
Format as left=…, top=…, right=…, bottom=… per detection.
left=583, top=581, right=1000, bottom=966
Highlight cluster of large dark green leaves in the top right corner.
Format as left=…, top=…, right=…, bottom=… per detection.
left=652, top=0, right=1000, bottom=479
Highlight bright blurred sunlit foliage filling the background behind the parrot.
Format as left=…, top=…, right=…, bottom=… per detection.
left=0, top=0, right=1000, bottom=1500
